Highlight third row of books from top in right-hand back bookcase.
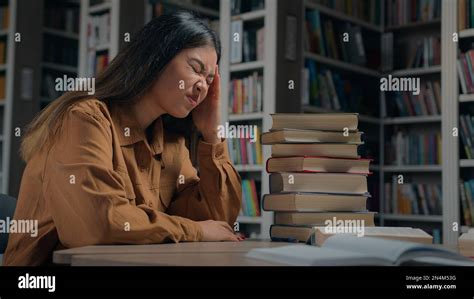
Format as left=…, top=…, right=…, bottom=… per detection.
left=389, top=81, right=441, bottom=116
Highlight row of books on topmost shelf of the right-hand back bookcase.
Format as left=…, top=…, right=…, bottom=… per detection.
left=385, top=0, right=441, bottom=27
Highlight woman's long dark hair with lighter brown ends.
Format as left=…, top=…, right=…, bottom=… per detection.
left=20, top=11, right=221, bottom=162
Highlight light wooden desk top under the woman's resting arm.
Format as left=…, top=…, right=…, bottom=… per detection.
left=53, top=241, right=294, bottom=266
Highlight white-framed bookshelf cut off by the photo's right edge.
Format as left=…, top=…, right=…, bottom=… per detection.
left=452, top=1, right=474, bottom=243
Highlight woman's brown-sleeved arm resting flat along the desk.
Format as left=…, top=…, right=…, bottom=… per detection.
left=43, top=109, right=203, bottom=247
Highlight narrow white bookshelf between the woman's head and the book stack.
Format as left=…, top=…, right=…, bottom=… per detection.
left=219, top=0, right=277, bottom=238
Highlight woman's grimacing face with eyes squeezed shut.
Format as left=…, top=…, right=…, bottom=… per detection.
left=150, top=47, right=217, bottom=118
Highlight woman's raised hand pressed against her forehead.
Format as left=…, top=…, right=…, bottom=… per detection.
left=192, top=65, right=221, bottom=144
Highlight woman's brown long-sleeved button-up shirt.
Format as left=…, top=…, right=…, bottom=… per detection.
left=4, top=100, right=242, bottom=265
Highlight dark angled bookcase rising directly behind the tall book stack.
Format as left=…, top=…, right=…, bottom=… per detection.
left=300, top=0, right=384, bottom=225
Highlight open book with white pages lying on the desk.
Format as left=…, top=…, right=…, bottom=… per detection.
left=246, top=234, right=474, bottom=266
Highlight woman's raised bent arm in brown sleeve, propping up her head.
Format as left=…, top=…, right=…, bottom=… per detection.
left=167, top=140, right=242, bottom=226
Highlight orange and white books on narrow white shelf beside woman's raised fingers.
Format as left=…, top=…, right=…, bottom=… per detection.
left=228, top=71, right=263, bottom=114
